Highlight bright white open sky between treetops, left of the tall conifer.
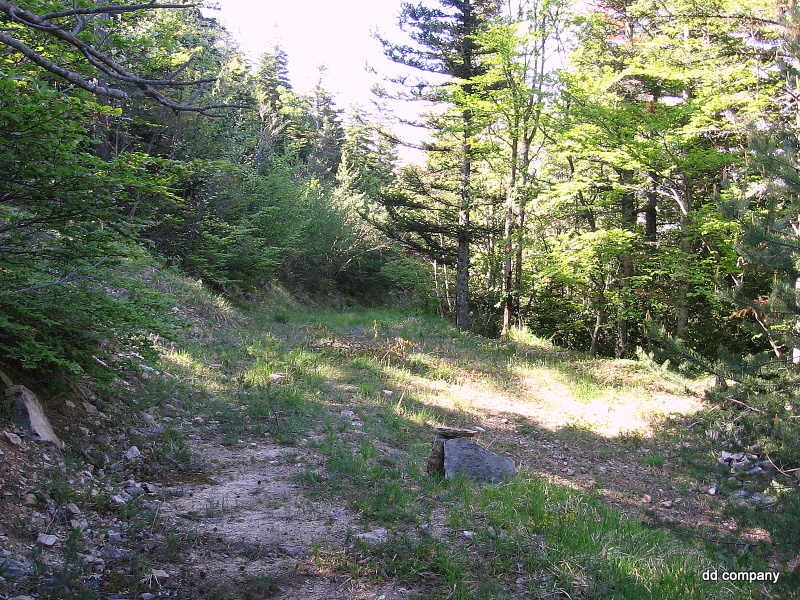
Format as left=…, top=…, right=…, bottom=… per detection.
left=204, top=0, right=410, bottom=108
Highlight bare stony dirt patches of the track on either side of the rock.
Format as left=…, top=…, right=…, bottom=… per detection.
left=150, top=364, right=726, bottom=600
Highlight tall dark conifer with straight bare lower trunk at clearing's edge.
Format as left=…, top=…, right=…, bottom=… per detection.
left=382, top=0, right=499, bottom=329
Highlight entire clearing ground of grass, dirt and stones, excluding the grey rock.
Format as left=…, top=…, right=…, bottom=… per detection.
left=0, top=284, right=798, bottom=600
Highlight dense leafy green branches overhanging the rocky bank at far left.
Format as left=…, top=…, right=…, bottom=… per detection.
left=0, top=72, right=177, bottom=376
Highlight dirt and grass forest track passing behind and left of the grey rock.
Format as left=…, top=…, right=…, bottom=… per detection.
left=152, top=310, right=759, bottom=600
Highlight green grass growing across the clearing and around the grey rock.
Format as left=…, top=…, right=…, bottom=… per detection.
left=167, top=300, right=780, bottom=600
